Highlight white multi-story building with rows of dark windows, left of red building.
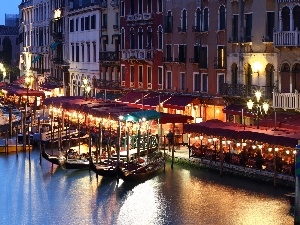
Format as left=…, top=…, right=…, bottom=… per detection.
left=67, top=0, right=107, bottom=95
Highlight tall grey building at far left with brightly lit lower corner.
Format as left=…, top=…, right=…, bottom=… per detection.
left=19, top=0, right=52, bottom=88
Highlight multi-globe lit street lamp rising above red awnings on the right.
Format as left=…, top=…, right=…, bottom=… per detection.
left=247, top=90, right=269, bottom=129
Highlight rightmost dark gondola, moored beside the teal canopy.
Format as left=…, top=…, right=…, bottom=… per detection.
left=118, top=152, right=166, bottom=181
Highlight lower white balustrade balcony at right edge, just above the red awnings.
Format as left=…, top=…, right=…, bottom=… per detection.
left=272, top=92, right=300, bottom=110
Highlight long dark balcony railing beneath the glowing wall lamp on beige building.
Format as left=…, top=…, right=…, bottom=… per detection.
left=219, top=83, right=275, bottom=100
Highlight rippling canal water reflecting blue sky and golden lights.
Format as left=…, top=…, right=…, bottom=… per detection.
left=0, top=150, right=294, bottom=225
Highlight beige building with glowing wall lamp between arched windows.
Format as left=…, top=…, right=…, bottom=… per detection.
left=223, top=0, right=278, bottom=99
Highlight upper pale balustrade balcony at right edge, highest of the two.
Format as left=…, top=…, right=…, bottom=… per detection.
left=273, top=31, right=300, bottom=47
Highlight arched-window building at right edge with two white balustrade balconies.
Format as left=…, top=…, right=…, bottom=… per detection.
left=273, top=0, right=300, bottom=111
